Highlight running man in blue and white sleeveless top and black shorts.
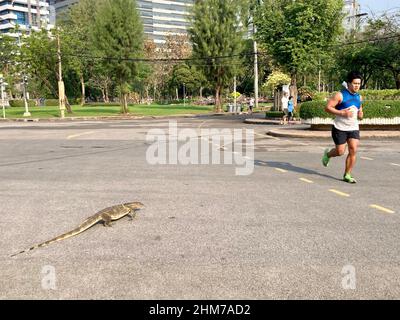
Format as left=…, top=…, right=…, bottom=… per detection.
left=322, top=72, right=364, bottom=183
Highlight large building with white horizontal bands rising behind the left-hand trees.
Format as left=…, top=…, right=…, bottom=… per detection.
left=50, top=0, right=195, bottom=44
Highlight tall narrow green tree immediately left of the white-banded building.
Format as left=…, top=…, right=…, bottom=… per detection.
left=93, top=0, right=143, bottom=113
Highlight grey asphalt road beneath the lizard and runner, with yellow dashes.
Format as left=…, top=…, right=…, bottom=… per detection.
left=0, top=116, right=400, bottom=299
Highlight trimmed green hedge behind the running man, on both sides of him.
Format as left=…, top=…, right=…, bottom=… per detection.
left=300, top=100, right=400, bottom=120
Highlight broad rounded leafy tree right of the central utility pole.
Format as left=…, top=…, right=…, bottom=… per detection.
left=255, top=0, right=343, bottom=102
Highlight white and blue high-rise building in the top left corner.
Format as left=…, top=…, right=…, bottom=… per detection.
left=0, top=0, right=52, bottom=37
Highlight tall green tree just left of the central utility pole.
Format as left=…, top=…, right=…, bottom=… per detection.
left=189, top=0, right=248, bottom=112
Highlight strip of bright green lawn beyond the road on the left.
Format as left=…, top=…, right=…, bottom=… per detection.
left=2, top=105, right=214, bottom=119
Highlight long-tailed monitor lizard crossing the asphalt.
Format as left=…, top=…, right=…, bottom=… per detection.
left=11, top=202, right=144, bottom=257
